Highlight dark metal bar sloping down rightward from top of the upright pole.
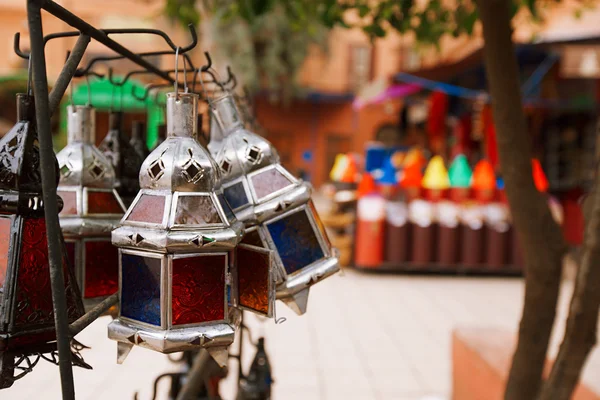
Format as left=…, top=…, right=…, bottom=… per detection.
left=42, top=0, right=174, bottom=83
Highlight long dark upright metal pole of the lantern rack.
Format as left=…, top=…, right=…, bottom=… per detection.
left=27, top=0, right=75, bottom=400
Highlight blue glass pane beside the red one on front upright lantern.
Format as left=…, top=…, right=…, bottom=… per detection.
left=121, top=254, right=161, bottom=326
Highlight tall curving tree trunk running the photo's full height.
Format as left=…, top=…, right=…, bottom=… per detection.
left=477, top=0, right=567, bottom=400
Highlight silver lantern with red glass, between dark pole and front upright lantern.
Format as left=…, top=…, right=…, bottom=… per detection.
left=57, top=106, right=125, bottom=309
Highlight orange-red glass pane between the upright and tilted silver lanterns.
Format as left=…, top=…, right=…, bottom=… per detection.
left=237, top=246, right=271, bottom=314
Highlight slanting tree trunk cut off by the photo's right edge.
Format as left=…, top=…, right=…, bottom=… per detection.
left=540, top=156, right=600, bottom=400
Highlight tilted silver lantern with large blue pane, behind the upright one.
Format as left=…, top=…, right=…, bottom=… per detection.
left=209, top=94, right=339, bottom=314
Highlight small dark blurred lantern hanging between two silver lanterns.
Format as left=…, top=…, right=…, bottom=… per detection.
left=98, top=112, right=144, bottom=206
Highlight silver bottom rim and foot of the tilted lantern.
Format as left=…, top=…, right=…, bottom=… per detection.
left=277, top=257, right=340, bottom=315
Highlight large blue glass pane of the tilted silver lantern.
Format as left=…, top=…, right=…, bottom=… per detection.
left=267, top=210, right=324, bottom=274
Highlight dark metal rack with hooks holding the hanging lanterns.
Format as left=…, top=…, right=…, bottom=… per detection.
left=19, top=0, right=220, bottom=400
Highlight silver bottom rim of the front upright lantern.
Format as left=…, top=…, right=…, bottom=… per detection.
left=108, top=318, right=235, bottom=362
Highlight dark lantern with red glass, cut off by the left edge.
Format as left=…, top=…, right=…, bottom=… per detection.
left=0, top=94, right=83, bottom=388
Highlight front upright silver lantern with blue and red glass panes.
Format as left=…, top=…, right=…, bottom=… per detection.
left=108, top=93, right=243, bottom=365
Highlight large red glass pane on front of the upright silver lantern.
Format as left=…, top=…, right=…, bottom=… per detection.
left=172, top=255, right=227, bottom=325
